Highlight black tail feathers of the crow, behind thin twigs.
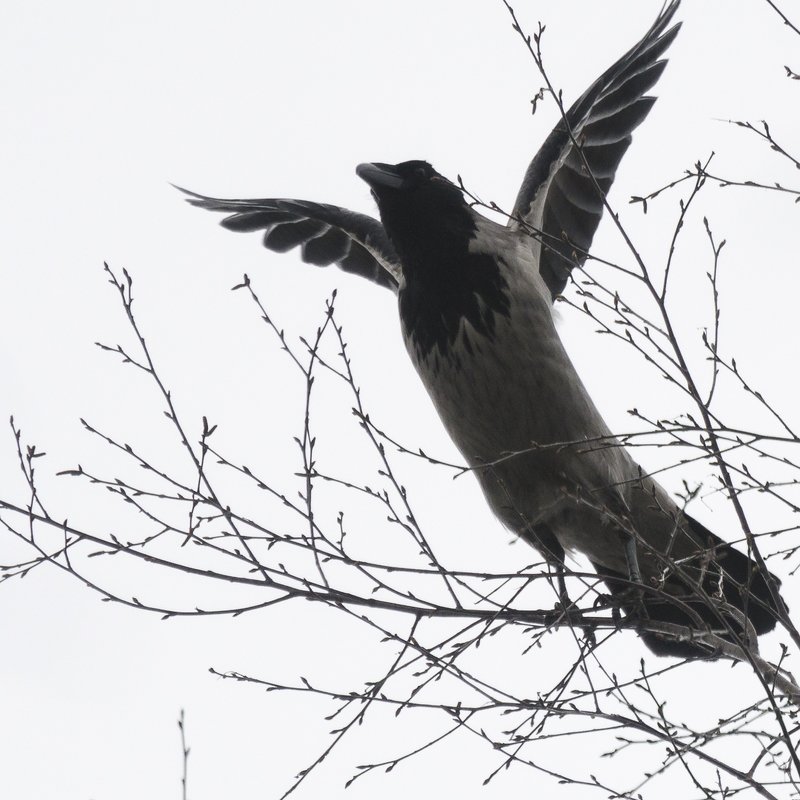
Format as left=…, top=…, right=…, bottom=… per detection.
left=592, top=516, right=786, bottom=658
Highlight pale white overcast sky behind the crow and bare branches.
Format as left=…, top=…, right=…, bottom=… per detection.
left=0, top=0, right=800, bottom=800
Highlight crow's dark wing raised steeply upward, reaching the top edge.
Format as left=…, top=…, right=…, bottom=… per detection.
left=509, top=0, right=680, bottom=298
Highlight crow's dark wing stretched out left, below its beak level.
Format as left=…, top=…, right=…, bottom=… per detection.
left=176, top=186, right=402, bottom=292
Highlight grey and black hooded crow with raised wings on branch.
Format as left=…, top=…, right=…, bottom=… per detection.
left=180, top=0, right=783, bottom=658
